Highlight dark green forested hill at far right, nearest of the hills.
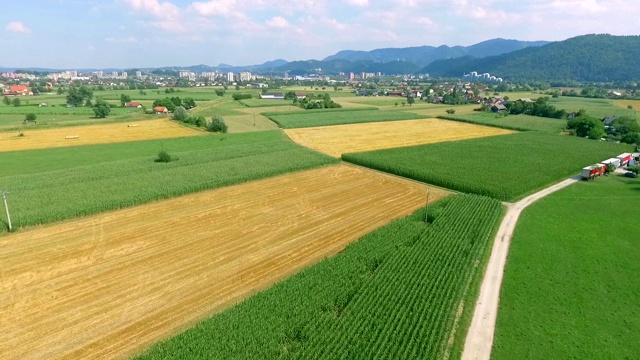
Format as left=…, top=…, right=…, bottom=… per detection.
left=420, top=35, right=640, bottom=82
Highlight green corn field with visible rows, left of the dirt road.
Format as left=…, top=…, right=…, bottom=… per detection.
left=139, top=191, right=501, bottom=359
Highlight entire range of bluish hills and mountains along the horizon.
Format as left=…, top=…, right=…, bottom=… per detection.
left=0, top=34, right=640, bottom=82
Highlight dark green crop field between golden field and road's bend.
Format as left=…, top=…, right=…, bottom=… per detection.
left=342, top=131, right=633, bottom=201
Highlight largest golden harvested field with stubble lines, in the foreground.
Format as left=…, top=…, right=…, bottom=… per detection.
left=0, top=165, right=447, bottom=359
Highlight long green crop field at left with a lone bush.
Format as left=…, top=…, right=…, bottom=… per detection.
left=0, top=132, right=336, bottom=229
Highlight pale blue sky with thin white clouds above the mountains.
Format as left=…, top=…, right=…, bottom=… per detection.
left=0, top=0, right=640, bottom=69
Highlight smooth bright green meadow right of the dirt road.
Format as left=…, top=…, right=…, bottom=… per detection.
left=492, top=175, right=640, bottom=360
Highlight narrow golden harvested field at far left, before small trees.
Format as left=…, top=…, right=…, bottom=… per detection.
left=0, top=120, right=202, bottom=152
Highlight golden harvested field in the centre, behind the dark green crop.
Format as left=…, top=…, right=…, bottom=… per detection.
left=285, top=119, right=513, bottom=157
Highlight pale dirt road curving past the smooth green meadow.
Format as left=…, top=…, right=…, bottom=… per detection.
left=462, top=176, right=580, bottom=360
